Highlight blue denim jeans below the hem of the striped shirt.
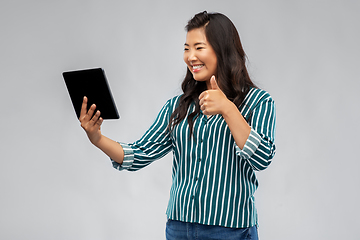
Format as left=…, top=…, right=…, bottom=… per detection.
left=166, top=219, right=258, bottom=240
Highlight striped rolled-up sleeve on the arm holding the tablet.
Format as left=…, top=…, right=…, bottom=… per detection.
left=111, top=100, right=176, bottom=171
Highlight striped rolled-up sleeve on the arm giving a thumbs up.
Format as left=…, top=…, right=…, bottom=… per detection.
left=236, top=96, right=276, bottom=171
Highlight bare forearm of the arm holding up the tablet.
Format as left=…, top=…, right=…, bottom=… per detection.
left=93, top=135, right=124, bottom=164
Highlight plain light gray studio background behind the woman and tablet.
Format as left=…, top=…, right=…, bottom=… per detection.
left=0, top=0, right=360, bottom=240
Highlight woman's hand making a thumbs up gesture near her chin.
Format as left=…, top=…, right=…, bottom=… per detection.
left=199, top=76, right=231, bottom=115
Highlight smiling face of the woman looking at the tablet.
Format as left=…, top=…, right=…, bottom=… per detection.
left=184, top=28, right=217, bottom=89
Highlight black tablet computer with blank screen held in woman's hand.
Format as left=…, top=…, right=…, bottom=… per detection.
left=63, top=68, right=120, bottom=119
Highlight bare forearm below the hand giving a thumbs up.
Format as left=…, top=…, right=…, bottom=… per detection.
left=222, top=101, right=251, bottom=149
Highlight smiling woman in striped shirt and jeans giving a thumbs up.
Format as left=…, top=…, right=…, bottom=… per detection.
left=80, top=12, right=275, bottom=239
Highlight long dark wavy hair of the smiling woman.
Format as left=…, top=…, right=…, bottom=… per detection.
left=169, top=11, right=256, bottom=136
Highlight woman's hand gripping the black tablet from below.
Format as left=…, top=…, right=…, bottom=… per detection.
left=79, top=97, right=103, bottom=146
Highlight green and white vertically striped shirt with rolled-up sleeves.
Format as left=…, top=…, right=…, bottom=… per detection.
left=112, top=88, right=276, bottom=228
